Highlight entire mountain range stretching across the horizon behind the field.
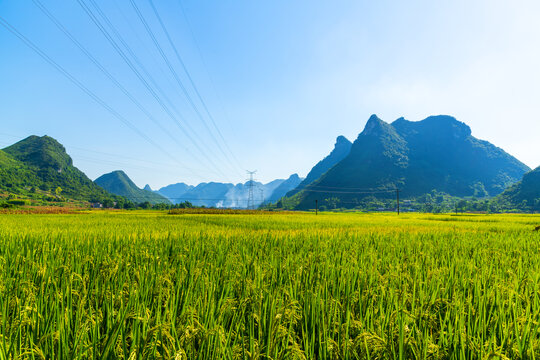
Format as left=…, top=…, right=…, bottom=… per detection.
left=0, top=126, right=540, bottom=211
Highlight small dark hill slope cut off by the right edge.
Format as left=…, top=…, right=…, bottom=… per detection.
left=494, top=167, right=540, bottom=211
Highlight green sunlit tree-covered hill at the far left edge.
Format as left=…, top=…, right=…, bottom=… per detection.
left=0, top=135, right=115, bottom=202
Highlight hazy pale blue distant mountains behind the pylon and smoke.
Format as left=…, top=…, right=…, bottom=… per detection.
left=157, top=174, right=302, bottom=208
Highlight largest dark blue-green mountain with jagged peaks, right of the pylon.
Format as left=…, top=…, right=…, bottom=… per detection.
left=293, top=115, right=530, bottom=208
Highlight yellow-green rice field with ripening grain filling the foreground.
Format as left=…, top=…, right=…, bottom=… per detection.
left=0, top=211, right=540, bottom=360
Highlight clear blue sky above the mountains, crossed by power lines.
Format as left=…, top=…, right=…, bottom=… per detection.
left=0, top=0, right=540, bottom=188
